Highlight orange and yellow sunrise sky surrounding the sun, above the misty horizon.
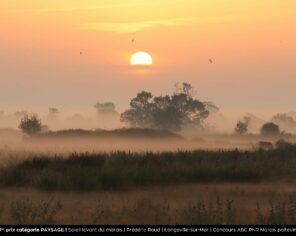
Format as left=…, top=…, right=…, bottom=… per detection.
left=0, top=0, right=296, bottom=117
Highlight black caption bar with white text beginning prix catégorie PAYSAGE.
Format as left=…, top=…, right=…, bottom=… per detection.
left=0, top=225, right=296, bottom=234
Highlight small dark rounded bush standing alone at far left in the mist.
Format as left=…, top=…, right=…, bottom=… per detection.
left=19, top=114, right=42, bottom=135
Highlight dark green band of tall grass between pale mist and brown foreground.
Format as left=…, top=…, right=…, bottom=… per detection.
left=0, top=144, right=296, bottom=191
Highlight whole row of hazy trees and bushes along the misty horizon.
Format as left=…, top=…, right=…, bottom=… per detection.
left=19, top=83, right=296, bottom=135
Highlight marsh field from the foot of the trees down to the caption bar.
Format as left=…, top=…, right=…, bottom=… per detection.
left=0, top=129, right=296, bottom=225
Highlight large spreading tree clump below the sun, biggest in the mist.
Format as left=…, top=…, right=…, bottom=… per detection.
left=121, top=83, right=209, bottom=131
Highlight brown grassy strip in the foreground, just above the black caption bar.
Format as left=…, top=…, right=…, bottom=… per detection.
left=0, top=183, right=296, bottom=225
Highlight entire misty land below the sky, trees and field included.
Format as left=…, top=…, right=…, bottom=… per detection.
left=0, top=82, right=296, bottom=225
